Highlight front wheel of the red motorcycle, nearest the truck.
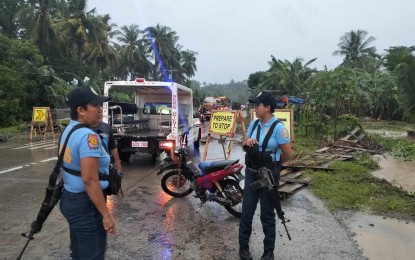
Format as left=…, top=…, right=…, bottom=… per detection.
left=161, top=169, right=193, bottom=198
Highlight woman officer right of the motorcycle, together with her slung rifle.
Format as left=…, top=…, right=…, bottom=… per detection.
left=239, top=91, right=293, bottom=260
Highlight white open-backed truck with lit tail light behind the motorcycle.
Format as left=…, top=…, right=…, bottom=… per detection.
left=102, top=78, right=201, bottom=162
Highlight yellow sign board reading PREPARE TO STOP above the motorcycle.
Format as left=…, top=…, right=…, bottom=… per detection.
left=209, top=110, right=237, bottom=135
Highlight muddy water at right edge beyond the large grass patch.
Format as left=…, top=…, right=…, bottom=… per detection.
left=372, top=153, right=415, bottom=192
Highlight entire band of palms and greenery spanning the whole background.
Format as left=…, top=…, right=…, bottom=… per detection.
left=0, top=0, right=415, bottom=134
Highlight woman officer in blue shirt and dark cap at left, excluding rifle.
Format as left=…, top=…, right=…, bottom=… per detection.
left=60, top=86, right=116, bottom=259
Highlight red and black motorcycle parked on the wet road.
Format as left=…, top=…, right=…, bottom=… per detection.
left=158, top=128, right=245, bottom=218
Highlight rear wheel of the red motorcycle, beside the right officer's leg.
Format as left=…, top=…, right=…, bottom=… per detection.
left=220, top=179, right=244, bottom=218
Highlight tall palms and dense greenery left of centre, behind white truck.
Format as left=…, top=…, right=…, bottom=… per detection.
left=0, top=0, right=197, bottom=127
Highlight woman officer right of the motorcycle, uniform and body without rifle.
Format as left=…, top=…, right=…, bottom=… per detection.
left=239, top=91, right=293, bottom=260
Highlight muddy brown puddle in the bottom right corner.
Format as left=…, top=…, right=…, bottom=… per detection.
left=345, top=213, right=415, bottom=260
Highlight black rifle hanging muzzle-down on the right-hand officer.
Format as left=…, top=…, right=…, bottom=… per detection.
left=250, top=167, right=291, bottom=240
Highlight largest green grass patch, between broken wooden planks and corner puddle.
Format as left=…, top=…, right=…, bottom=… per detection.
left=307, top=159, right=415, bottom=220
